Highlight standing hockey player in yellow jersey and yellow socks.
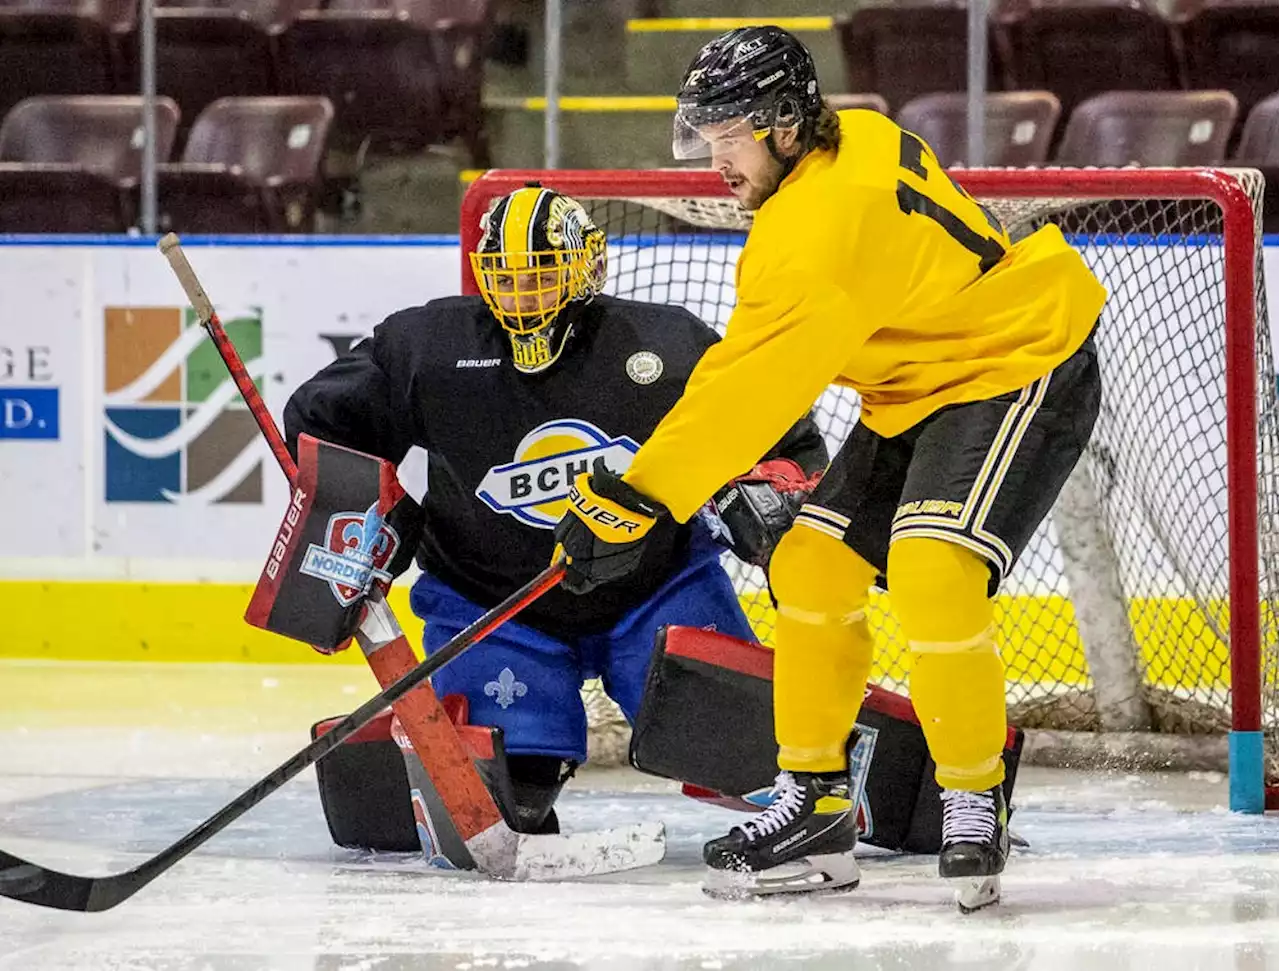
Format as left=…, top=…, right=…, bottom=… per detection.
left=558, top=27, right=1106, bottom=910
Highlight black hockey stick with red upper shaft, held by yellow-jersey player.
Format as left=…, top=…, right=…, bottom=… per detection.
left=0, top=563, right=564, bottom=911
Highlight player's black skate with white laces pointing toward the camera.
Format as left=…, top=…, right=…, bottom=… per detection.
left=938, top=785, right=1009, bottom=913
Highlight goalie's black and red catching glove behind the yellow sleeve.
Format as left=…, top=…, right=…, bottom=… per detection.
left=707, top=458, right=822, bottom=567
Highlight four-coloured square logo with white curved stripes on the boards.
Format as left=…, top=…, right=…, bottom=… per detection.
left=102, top=307, right=266, bottom=505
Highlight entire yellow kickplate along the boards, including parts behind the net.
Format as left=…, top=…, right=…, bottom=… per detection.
left=0, top=581, right=1264, bottom=690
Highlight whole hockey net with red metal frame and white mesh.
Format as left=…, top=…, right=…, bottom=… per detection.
left=463, top=169, right=1280, bottom=803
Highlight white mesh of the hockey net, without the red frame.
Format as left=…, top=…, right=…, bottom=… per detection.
left=563, top=171, right=1280, bottom=772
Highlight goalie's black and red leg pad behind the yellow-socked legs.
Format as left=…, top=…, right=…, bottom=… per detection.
left=630, top=627, right=1023, bottom=853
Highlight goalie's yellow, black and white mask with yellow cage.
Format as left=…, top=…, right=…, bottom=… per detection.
left=471, top=186, right=605, bottom=374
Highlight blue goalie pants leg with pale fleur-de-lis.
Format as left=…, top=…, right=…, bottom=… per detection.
left=410, top=573, right=586, bottom=764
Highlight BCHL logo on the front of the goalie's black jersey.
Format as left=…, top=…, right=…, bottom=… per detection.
left=476, top=418, right=640, bottom=530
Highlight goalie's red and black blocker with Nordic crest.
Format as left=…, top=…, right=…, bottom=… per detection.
left=244, top=435, right=422, bottom=651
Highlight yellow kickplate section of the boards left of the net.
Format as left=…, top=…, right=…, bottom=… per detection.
left=0, top=581, right=422, bottom=664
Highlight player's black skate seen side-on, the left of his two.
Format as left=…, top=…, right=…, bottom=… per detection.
left=703, top=771, right=860, bottom=898
